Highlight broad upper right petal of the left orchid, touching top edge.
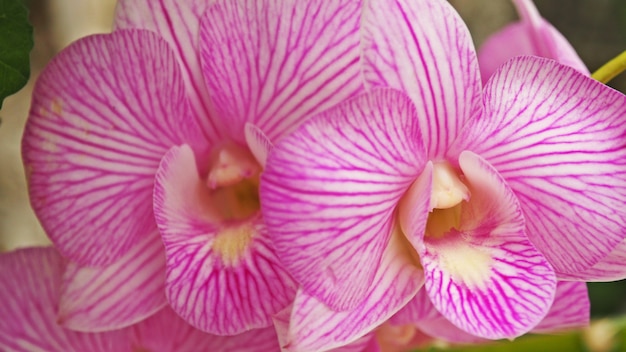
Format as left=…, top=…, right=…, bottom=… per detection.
left=195, top=0, right=362, bottom=142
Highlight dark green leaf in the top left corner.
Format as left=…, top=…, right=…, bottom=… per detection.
left=0, top=0, right=33, bottom=108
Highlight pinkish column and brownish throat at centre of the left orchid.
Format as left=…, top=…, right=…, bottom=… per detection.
left=206, top=143, right=261, bottom=222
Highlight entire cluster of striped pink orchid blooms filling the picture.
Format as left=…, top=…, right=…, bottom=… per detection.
left=0, top=0, right=626, bottom=352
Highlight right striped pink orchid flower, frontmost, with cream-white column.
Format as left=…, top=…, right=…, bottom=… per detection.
left=261, top=0, right=626, bottom=351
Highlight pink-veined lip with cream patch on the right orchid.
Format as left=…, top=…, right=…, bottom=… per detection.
left=420, top=152, right=556, bottom=339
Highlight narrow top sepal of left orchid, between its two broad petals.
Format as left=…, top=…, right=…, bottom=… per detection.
left=114, top=0, right=223, bottom=142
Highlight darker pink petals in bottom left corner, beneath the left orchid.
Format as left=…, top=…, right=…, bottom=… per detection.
left=0, top=247, right=278, bottom=352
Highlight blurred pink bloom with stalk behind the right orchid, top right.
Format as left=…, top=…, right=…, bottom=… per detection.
left=478, top=0, right=589, bottom=82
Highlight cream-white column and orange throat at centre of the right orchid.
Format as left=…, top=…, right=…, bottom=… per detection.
left=425, top=162, right=470, bottom=238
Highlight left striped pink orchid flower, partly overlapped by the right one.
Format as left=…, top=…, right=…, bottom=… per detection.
left=23, top=0, right=362, bottom=335
